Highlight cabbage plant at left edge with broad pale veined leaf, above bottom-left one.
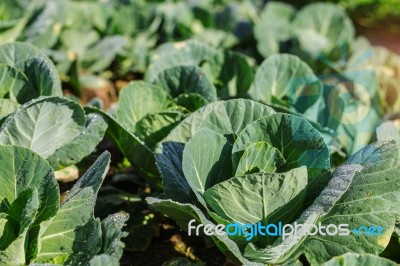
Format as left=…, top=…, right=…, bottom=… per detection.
left=0, top=42, right=108, bottom=170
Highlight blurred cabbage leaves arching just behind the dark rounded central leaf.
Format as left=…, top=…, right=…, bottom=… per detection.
left=145, top=39, right=253, bottom=99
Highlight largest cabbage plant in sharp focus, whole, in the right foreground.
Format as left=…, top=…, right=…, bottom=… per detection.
left=147, top=100, right=400, bottom=265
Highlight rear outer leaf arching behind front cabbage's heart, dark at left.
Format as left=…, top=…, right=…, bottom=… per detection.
left=156, top=99, right=275, bottom=202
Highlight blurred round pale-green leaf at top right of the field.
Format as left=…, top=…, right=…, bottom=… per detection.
left=293, top=3, right=354, bottom=56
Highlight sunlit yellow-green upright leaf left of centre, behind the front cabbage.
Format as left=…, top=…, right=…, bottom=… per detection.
left=115, top=81, right=169, bottom=131
